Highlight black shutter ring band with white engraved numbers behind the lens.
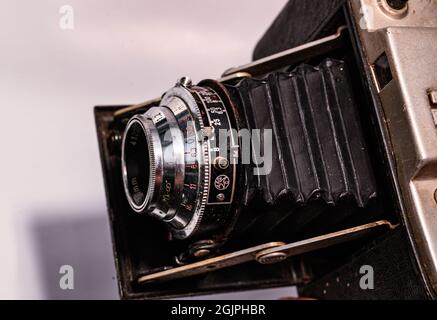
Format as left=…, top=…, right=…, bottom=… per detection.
left=193, top=87, right=236, bottom=205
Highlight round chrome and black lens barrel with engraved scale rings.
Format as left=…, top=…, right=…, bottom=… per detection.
left=122, top=81, right=238, bottom=239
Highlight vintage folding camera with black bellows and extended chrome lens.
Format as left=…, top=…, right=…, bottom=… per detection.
left=95, top=0, right=437, bottom=299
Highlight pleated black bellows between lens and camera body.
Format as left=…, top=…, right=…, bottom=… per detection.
left=228, top=59, right=376, bottom=207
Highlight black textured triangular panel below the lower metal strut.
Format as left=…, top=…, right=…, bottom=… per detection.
left=300, top=227, right=428, bottom=300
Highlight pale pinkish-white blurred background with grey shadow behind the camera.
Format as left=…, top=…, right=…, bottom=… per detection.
left=0, top=0, right=292, bottom=299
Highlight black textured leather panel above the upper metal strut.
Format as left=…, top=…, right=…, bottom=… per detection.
left=253, top=0, right=345, bottom=60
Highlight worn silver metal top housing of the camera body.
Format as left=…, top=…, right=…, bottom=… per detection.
left=350, top=0, right=437, bottom=294
